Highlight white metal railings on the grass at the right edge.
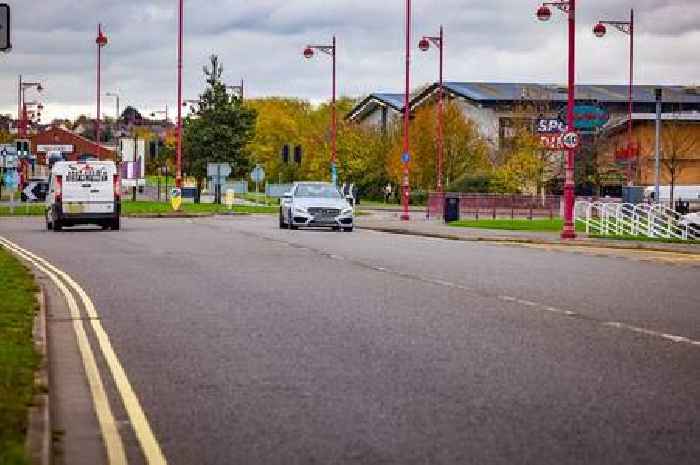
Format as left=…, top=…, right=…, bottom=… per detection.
left=574, top=201, right=700, bottom=240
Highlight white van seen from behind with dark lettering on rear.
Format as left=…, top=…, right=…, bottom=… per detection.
left=46, top=161, right=121, bottom=231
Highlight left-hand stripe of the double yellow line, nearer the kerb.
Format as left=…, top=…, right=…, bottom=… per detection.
left=0, top=238, right=127, bottom=465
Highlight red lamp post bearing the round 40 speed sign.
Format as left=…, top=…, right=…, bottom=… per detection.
left=537, top=0, right=576, bottom=239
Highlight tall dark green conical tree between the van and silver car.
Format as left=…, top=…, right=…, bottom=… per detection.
left=183, top=55, right=257, bottom=193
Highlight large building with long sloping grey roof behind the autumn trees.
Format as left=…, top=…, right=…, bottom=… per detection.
left=346, top=82, right=700, bottom=187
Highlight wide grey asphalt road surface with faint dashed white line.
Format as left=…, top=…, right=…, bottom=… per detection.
left=0, top=216, right=700, bottom=465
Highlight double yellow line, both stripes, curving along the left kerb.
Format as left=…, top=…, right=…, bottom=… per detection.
left=0, top=236, right=167, bottom=465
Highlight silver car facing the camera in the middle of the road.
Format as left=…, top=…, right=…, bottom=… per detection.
left=279, top=182, right=354, bottom=232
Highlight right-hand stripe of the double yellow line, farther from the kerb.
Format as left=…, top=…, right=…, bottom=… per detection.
left=0, top=237, right=167, bottom=465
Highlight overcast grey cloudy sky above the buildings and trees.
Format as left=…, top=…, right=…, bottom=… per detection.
left=5, top=0, right=700, bottom=121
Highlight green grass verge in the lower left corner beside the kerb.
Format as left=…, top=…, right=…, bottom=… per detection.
left=0, top=247, right=39, bottom=465
